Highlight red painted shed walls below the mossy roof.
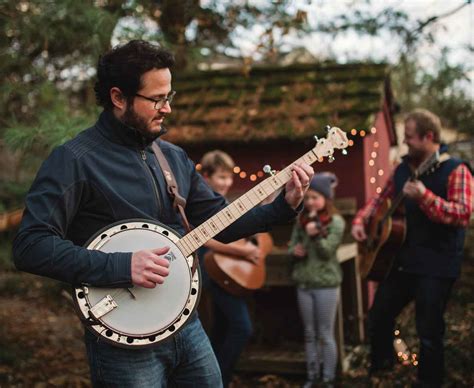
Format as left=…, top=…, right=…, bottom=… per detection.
left=185, top=119, right=390, bottom=207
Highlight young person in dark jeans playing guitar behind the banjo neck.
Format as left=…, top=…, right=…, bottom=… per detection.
left=199, top=150, right=271, bottom=387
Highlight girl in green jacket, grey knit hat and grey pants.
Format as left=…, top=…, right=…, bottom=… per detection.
left=289, top=172, right=345, bottom=387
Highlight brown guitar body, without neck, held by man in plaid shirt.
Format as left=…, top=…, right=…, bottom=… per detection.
left=358, top=198, right=406, bottom=281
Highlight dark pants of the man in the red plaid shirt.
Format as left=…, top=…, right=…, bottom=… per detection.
left=369, top=270, right=454, bottom=387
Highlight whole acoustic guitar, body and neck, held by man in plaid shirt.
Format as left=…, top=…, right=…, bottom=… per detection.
left=358, top=151, right=449, bottom=281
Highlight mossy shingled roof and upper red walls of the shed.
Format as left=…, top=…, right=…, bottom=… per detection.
left=165, top=63, right=396, bottom=205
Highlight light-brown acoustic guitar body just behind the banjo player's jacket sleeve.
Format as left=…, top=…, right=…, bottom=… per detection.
left=204, top=233, right=273, bottom=296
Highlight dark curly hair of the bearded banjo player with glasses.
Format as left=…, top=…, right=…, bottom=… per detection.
left=94, top=40, right=175, bottom=109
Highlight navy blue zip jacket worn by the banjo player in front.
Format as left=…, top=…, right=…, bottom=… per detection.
left=13, top=112, right=296, bottom=286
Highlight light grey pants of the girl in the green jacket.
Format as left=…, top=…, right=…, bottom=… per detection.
left=297, top=287, right=339, bottom=381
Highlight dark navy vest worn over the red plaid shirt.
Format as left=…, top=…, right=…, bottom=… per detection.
left=394, top=148, right=465, bottom=278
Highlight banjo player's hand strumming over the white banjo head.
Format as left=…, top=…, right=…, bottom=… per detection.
left=132, top=247, right=170, bottom=288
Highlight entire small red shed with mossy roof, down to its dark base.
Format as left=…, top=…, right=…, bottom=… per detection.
left=165, top=63, right=396, bottom=373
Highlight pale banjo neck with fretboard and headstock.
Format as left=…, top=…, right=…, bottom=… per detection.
left=176, top=127, right=348, bottom=257
